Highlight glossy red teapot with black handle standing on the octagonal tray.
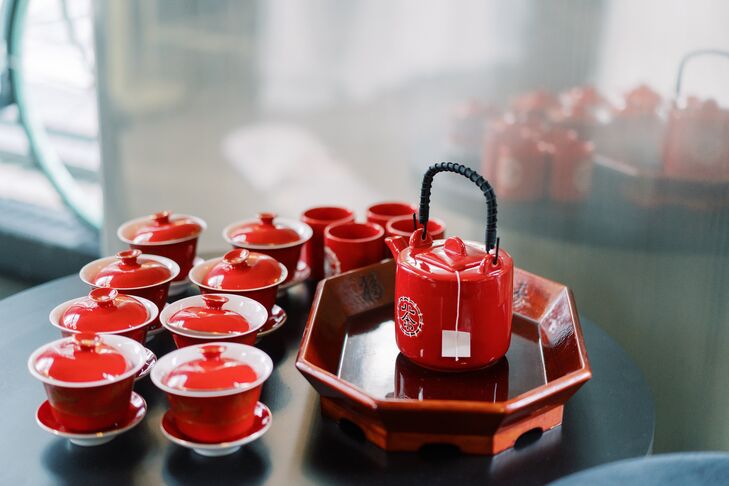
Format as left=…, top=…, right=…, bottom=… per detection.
left=385, top=162, right=514, bottom=371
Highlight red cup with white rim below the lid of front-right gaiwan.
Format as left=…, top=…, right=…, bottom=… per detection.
left=151, top=343, right=273, bottom=443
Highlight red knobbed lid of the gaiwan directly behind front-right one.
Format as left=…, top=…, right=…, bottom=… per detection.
left=168, top=294, right=251, bottom=335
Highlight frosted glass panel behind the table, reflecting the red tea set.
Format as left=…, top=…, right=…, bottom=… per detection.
left=96, top=0, right=729, bottom=450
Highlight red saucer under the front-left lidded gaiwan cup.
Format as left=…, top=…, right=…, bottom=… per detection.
left=35, top=392, right=147, bottom=447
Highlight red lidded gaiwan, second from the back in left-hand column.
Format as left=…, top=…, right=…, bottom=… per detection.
left=79, top=250, right=180, bottom=333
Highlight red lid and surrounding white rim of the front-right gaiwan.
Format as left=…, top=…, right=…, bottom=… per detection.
left=152, top=343, right=273, bottom=396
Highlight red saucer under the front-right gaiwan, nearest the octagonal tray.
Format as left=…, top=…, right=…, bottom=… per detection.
left=160, top=402, right=273, bottom=457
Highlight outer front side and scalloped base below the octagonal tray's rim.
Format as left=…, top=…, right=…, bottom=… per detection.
left=321, top=397, right=564, bottom=455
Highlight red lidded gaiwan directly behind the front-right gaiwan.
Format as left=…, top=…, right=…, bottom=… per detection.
left=160, top=294, right=268, bottom=348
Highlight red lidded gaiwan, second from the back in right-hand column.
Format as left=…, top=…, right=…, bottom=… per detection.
left=190, top=249, right=288, bottom=315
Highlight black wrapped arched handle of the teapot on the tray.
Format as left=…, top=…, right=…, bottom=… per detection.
left=418, top=162, right=496, bottom=251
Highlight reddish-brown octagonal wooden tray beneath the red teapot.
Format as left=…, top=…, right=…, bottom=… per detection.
left=296, top=260, right=592, bottom=454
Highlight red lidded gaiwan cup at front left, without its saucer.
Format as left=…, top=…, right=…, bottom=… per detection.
left=28, top=334, right=146, bottom=433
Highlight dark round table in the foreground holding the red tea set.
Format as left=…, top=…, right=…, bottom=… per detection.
left=0, top=276, right=655, bottom=486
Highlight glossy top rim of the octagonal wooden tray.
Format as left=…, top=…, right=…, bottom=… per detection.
left=296, top=258, right=592, bottom=415
